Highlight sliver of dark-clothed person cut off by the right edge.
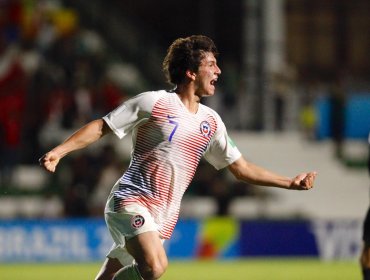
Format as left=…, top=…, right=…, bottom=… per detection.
left=360, top=132, right=370, bottom=280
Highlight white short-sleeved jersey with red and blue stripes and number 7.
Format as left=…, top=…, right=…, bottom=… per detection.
left=103, top=90, right=241, bottom=238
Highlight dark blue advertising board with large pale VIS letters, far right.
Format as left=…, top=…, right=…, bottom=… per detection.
left=240, top=220, right=362, bottom=260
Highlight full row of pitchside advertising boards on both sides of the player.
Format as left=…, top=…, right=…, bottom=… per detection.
left=0, top=218, right=362, bottom=263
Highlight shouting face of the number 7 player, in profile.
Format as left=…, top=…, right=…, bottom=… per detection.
left=195, top=52, right=221, bottom=97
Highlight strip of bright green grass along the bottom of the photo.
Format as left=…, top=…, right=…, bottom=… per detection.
left=0, top=259, right=361, bottom=280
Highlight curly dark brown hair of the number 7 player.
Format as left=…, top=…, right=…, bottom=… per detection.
left=162, top=35, right=218, bottom=85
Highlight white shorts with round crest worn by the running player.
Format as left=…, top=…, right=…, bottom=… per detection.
left=105, top=204, right=158, bottom=266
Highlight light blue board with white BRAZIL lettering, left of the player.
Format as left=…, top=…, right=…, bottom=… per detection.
left=0, top=219, right=112, bottom=262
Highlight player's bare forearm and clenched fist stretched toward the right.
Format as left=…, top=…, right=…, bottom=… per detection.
left=228, top=157, right=317, bottom=190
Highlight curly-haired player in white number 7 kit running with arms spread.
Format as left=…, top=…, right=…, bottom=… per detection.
left=40, top=35, right=316, bottom=280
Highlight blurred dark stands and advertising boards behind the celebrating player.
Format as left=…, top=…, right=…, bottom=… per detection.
left=0, top=0, right=370, bottom=279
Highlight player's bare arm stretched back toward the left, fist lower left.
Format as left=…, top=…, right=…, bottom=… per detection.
left=39, top=119, right=111, bottom=172
